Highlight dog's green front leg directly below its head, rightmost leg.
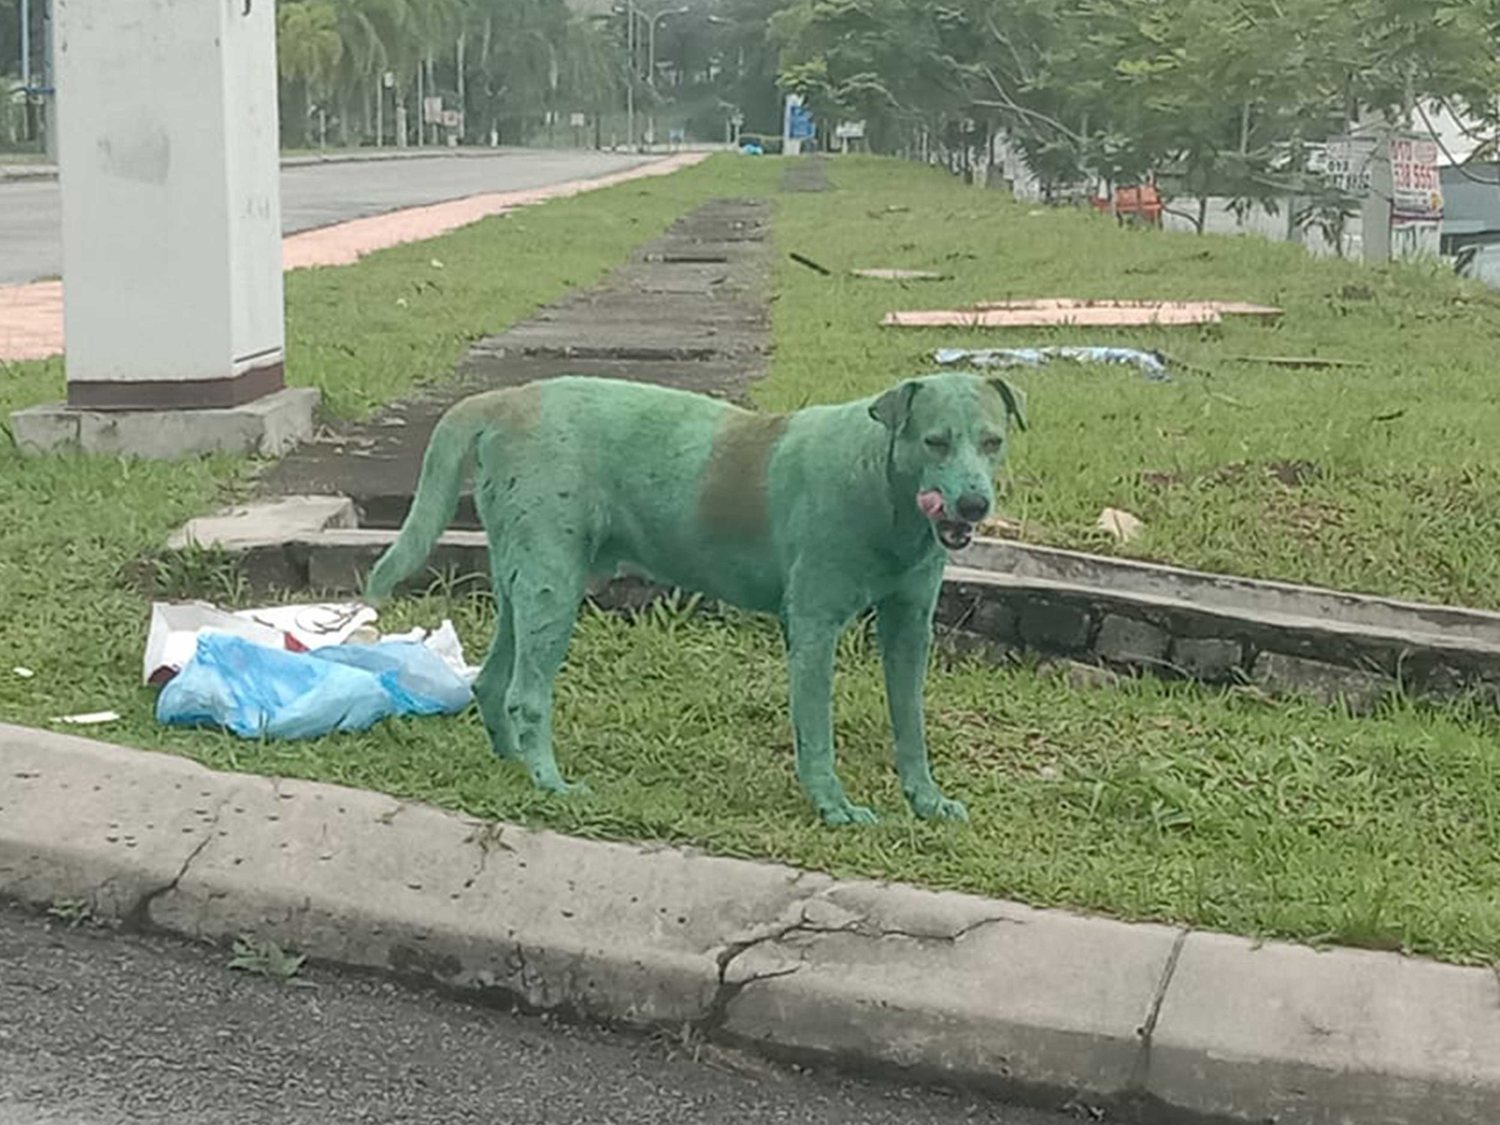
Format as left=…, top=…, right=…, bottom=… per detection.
left=876, top=585, right=969, bottom=821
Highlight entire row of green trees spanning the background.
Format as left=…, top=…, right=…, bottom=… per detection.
left=0, top=0, right=1500, bottom=205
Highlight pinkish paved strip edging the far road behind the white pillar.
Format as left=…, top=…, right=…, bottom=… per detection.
left=0, top=150, right=708, bottom=363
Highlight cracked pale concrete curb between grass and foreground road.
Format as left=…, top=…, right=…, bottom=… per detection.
left=0, top=725, right=1500, bottom=1125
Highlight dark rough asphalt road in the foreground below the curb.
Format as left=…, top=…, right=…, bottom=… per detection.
left=0, top=905, right=1077, bottom=1125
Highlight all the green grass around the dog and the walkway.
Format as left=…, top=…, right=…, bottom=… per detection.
left=0, top=159, right=1500, bottom=963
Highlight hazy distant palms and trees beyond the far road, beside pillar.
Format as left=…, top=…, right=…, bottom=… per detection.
left=278, top=0, right=777, bottom=144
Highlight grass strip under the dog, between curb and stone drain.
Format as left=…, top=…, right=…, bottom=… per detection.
left=49, top=596, right=1500, bottom=963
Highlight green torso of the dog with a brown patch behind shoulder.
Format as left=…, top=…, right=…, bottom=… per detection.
left=464, top=378, right=944, bottom=618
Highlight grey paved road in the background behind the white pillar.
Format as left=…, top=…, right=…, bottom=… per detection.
left=0, top=149, right=648, bottom=285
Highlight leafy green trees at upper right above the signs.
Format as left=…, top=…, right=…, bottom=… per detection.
left=770, top=0, right=1500, bottom=216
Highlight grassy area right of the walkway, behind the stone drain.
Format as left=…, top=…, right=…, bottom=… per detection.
left=761, top=159, right=1500, bottom=609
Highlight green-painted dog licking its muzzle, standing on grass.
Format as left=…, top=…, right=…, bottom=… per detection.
left=366, top=372, right=1026, bottom=825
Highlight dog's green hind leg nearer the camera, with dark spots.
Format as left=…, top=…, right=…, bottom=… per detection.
left=506, top=561, right=587, bottom=794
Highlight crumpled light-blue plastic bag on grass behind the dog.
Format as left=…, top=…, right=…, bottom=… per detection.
left=156, top=633, right=473, bottom=740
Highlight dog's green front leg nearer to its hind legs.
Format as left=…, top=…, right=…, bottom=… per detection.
left=782, top=612, right=875, bottom=825
